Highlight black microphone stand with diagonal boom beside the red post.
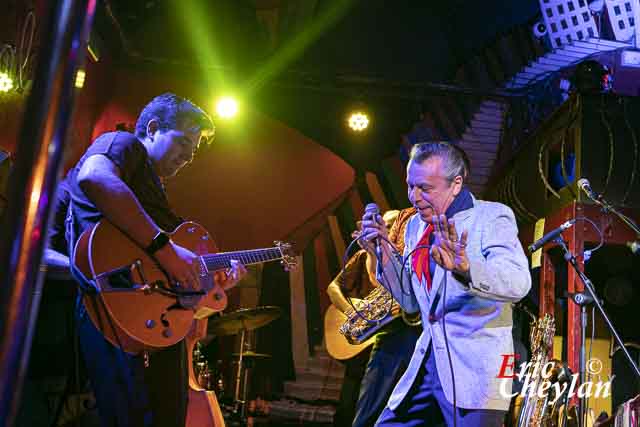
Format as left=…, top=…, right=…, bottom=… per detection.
left=555, top=236, right=640, bottom=425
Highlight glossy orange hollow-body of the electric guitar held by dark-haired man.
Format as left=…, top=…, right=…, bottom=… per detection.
left=74, top=220, right=227, bottom=354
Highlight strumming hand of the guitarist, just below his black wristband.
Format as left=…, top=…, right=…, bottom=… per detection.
left=155, top=241, right=200, bottom=290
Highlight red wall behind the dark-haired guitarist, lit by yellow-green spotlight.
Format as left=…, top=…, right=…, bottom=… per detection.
left=5, top=57, right=354, bottom=256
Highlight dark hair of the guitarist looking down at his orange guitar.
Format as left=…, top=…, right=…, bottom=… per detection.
left=135, top=93, right=215, bottom=144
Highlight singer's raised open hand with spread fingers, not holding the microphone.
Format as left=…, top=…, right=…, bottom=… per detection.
left=431, top=215, right=469, bottom=276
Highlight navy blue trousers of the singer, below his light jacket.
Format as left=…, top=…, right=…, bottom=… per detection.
left=376, top=347, right=506, bottom=427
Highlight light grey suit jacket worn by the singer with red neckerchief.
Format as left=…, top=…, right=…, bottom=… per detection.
left=378, top=199, right=531, bottom=410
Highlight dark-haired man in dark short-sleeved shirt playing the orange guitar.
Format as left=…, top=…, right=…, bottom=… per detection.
left=55, top=93, right=246, bottom=427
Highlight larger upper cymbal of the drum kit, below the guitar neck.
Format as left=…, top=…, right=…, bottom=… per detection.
left=207, top=306, right=282, bottom=336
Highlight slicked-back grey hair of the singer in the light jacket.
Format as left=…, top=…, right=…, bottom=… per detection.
left=409, top=141, right=471, bottom=182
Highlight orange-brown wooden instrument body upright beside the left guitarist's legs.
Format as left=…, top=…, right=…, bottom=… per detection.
left=185, top=319, right=225, bottom=427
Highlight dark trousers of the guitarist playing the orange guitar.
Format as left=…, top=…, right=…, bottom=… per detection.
left=77, top=304, right=188, bottom=427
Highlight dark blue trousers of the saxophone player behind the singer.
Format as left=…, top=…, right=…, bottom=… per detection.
left=353, top=319, right=420, bottom=427
